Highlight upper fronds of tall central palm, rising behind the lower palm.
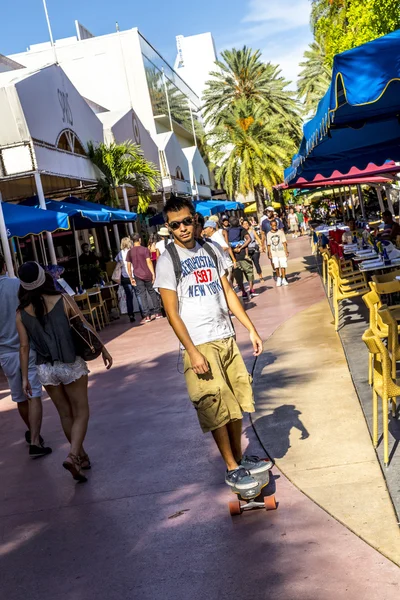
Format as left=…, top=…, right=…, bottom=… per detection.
left=203, top=46, right=299, bottom=133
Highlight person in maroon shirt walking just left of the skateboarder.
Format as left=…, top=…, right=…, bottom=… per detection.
left=126, top=233, right=162, bottom=324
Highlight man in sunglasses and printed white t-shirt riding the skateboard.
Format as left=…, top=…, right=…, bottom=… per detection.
left=154, top=198, right=272, bottom=491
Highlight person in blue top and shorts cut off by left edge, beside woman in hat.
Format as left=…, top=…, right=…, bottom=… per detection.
left=0, top=255, right=51, bottom=458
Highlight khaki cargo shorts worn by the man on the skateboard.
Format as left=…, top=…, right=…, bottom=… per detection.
left=183, top=337, right=254, bottom=433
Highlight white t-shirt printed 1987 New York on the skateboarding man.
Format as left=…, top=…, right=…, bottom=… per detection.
left=154, top=243, right=235, bottom=346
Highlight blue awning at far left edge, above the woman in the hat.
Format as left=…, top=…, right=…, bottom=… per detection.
left=1, top=202, right=70, bottom=238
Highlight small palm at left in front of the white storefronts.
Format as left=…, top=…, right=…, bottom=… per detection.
left=88, top=140, right=160, bottom=213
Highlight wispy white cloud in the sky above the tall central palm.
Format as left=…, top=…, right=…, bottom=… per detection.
left=216, top=0, right=312, bottom=89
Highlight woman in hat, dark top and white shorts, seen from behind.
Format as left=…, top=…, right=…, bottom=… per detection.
left=17, top=262, right=112, bottom=481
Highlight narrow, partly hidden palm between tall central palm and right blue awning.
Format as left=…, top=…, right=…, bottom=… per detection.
left=297, top=41, right=331, bottom=115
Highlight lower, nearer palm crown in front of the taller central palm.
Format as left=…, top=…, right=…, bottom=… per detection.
left=209, top=99, right=296, bottom=217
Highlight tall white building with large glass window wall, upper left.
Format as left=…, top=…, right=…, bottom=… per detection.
left=9, top=28, right=211, bottom=198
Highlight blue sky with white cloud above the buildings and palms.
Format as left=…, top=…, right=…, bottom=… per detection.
left=0, top=0, right=311, bottom=86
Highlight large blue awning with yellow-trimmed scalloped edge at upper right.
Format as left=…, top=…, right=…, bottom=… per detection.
left=285, top=30, right=400, bottom=184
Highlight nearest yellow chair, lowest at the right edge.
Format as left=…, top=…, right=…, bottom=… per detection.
left=362, top=329, right=400, bottom=467
